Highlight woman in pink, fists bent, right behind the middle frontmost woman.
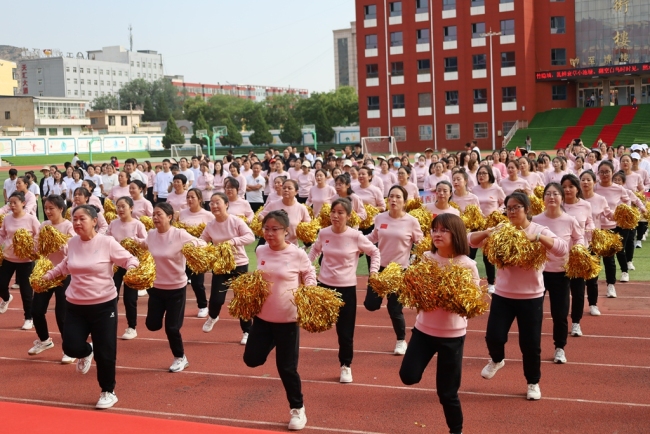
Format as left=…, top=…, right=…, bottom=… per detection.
left=309, top=198, right=380, bottom=383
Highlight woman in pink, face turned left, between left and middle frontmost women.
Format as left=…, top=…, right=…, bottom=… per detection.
left=145, top=202, right=206, bottom=372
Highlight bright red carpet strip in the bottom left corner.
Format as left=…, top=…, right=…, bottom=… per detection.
left=0, top=402, right=271, bottom=434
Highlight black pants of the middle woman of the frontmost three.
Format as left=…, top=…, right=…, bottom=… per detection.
left=244, top=317, right=303, bottom=408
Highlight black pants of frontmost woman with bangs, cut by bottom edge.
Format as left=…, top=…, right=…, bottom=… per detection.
left=399, top=328, right=465, bottom=433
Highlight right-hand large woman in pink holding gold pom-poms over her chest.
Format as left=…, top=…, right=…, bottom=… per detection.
left=469, top=192, right=569, bottom=400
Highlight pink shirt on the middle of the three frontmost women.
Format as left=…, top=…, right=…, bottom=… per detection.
left=256, top=244, right=317, bottom=323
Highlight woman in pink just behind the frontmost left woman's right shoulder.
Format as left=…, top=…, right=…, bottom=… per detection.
left=106, top=195, right=147, bottom=340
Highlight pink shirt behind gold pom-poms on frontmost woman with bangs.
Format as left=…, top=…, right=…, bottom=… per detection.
left=415, top=252, right=481, bottom=338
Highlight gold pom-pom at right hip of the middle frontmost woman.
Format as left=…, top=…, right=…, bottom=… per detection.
left=293, top=286, right=345, bottom=333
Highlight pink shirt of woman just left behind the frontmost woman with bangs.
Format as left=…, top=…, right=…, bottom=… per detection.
left=368, top=212, right=424, bottom=268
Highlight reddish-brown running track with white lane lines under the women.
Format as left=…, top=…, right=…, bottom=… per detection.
left=0, top=276, right=650, bottom=433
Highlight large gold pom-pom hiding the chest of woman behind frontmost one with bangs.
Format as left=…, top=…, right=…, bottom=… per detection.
left=483, top=223, right=546, bottom=270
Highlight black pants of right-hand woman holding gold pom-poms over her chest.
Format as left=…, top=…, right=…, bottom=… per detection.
left=485, top=294, right=544, bottom=384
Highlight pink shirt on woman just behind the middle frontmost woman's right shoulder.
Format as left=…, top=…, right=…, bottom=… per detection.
left=309, top=226, right=380, bottom=288
